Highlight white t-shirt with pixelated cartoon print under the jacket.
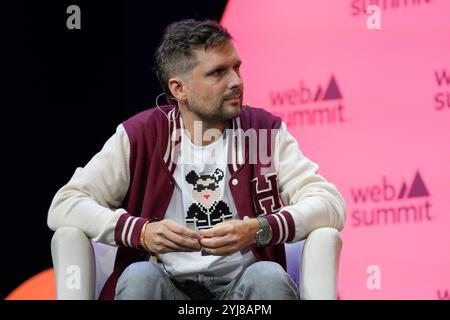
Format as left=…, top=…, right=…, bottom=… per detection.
left=159, top=121, right=256, bottom=281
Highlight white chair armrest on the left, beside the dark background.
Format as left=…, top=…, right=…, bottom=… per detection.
left=51, top=227, right=95, bottom=300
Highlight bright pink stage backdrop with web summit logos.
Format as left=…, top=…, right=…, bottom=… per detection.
left=222, top=0, right=450, bottom=299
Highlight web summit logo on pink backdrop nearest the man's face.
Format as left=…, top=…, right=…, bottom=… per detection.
left=270, top=76, right=345, bottom=127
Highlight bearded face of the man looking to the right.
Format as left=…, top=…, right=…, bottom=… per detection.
left=186, top=41, right=244, bottom=123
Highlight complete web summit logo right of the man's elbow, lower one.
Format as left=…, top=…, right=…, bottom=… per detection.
left=350, top=172, right=433, bottom=227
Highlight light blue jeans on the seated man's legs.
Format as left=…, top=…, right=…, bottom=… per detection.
left=115, top=261, right=299, bottom=300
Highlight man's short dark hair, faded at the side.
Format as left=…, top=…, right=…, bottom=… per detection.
left=154, top=19, right=232, bottom=103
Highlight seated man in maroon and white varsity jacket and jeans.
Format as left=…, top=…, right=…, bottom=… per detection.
left=48, top=20, right=345, bottom=299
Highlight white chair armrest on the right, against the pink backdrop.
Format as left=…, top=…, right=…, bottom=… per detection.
left=300, top=228, right=342, bottom=300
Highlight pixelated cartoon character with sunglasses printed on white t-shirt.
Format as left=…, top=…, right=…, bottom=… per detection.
left=186, top=169, right=233, bottom=230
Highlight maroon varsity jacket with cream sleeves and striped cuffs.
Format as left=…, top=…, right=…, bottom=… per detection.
left=47, top=105, right=346, bottom=299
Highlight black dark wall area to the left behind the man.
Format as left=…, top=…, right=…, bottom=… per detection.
left=8, top=0, right=226, bottom=297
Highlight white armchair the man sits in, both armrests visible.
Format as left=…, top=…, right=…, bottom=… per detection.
left=51, top=227, right=342, bottom=300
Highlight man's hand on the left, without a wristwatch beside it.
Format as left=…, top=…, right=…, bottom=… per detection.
left=144, top=219, right=201, bottom=254
